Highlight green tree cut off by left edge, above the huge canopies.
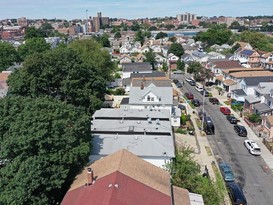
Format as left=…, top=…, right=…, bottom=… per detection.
left=0, top=41, right=19, bottom=72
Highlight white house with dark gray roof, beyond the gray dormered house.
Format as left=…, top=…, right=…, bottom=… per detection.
left=121, top=62, right=153, bottom=78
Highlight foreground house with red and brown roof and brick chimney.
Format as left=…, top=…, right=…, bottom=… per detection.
left=61, top=150, right=201, bottom=205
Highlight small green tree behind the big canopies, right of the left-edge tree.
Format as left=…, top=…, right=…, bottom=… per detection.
left=18, top=37, right=50, bottom=61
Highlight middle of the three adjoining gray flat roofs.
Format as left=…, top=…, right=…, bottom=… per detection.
left=91, top=120, right=172, bottom=135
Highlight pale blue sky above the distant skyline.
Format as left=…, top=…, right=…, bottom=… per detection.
left=0, top=0, right=273, bottom=20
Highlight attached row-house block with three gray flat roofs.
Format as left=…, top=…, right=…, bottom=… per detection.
left=89, top=107, right=175, bottom=168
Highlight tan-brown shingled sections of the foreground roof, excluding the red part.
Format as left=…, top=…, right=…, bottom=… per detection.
left=65, top=149, right=190, bottom=205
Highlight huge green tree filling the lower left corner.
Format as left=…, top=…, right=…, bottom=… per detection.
left=0, top=97, right=91, bottom=205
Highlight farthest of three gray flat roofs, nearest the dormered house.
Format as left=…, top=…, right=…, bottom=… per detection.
left=93, top=108, right=170, bottom=119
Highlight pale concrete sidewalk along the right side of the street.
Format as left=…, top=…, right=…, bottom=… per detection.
left=209, top=88, right=273, bottom=171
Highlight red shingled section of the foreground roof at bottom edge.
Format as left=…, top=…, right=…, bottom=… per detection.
left=61, top=171, right=171, bottom=205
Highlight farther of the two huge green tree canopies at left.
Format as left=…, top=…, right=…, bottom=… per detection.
left=8, top=40, right=112, bottom=114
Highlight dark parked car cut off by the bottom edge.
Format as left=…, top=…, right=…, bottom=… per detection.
left=226, top=182, right=247, bottom=205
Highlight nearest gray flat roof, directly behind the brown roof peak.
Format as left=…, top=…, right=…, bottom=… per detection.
left=91, top=134, right=175, bottom=158
